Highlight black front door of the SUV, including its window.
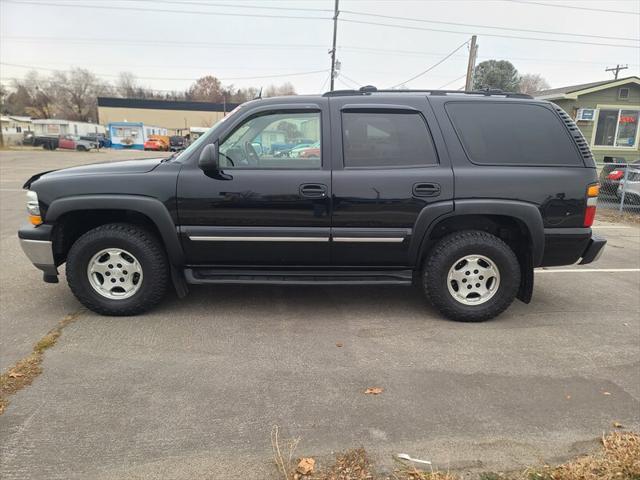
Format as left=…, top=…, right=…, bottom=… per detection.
left=177, top=104, right=331, bottom=267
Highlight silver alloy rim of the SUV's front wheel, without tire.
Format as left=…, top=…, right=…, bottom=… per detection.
left=87, top=248, right=142, bottom=300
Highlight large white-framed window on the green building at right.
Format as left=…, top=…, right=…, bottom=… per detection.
left=594, top=109, right=640, bottom=148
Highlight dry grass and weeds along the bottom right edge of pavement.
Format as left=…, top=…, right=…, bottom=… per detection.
left=272, top=434, right=640, bottom=480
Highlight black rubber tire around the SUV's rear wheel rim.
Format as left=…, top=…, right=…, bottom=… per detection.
left=422, top=230, right=520, bottom=322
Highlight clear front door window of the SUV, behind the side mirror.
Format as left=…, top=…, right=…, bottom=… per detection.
left=219, top=112, right=322, bottom=169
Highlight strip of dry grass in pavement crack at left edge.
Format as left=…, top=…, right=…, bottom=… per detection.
left=0, top=310, right=83, bottom=415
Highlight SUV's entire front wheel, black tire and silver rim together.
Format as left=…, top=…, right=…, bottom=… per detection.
left=66, top=223, right=169, bottom=315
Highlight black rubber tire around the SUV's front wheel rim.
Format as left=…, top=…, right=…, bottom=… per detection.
left=66, top=223, right=169, bottom=316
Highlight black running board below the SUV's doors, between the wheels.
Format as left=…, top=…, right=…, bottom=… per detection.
left=184, top=268, right=413, bottom=285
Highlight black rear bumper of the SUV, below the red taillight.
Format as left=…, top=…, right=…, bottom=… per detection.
left=540, top=228, right=607, bottom=267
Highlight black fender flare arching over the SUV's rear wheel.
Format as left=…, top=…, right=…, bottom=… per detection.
left=416, top=199, right=544, bottom=266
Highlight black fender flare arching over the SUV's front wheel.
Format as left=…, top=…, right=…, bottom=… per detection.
left=45, top=194, right=184, bottom=266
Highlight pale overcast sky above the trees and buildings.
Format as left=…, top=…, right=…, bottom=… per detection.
left=0, top=0, right=640, bottom=94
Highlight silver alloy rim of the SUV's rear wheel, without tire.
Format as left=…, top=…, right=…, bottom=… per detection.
left=447, top=255, right=500, bottom=305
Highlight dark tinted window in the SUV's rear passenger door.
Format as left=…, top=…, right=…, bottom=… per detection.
left=342, top=112, right=438, bottom=167
